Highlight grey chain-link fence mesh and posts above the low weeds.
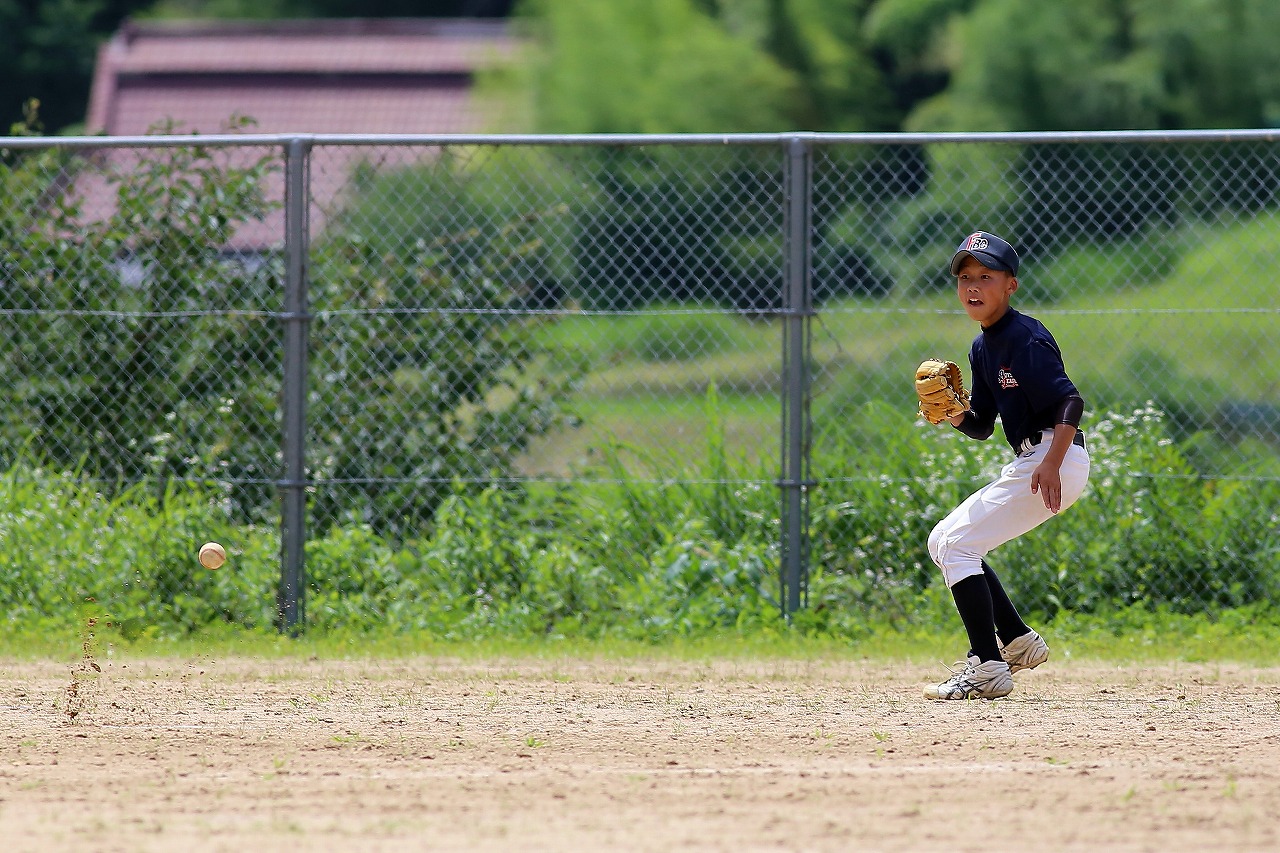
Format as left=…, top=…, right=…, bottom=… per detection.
left=0, top=132, right=1280, bottom=622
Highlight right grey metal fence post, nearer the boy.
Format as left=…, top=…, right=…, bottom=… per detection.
left=778, top=136, right=813, bottom=619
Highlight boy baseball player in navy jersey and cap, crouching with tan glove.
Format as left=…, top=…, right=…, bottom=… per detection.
left=916, top=231, right=1089, bottom=699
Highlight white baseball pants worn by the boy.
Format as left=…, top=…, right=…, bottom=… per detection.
left=929, top=430, right=1089, bottom=588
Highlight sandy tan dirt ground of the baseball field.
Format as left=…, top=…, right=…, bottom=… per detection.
left=0, top=654, right=1280, bottom=853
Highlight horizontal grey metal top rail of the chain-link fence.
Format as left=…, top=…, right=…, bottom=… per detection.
left=0, top=128, right=1280, bottom=150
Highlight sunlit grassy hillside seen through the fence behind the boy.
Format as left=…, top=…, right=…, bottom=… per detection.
left=522, top=215, right=1280, bottom=474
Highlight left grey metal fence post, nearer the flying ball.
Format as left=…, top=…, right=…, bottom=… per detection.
left=276, top=137, right=311, bottom=633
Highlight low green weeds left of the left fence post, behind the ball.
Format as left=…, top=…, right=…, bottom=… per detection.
left=0, top=462, right=279, bottom=637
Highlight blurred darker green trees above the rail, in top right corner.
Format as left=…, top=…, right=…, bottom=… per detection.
left=906, top=0, right=1280, bottom=131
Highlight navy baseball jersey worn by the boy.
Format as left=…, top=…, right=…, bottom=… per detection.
left=969, top=309, right=1079, bottom=451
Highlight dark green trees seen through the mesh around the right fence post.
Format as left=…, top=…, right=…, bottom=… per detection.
left=573, top=146, right=921, bottom=311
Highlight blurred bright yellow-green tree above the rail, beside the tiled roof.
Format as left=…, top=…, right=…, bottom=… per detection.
left=504, top=0, right=904, bottom=133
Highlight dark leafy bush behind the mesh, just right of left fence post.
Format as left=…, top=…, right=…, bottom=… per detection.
left=299, top=158, right=579, bottom=538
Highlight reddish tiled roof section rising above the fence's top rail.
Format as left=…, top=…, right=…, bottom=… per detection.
left=87, top=19, right=517, bottom=136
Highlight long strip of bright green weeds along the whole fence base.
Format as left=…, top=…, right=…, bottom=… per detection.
left=0, top=406, right=1280, bottom=640
